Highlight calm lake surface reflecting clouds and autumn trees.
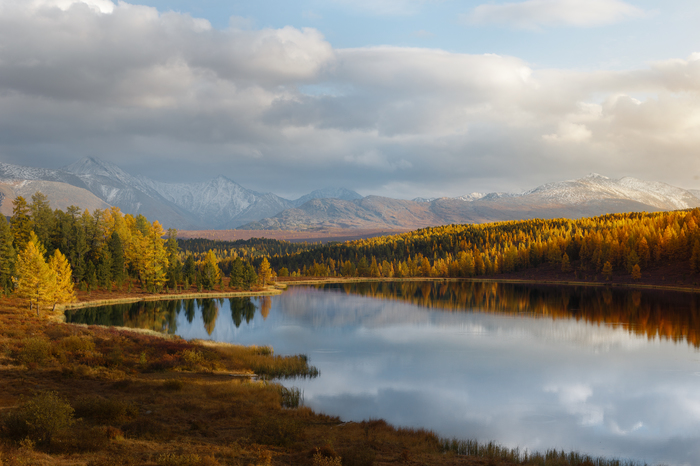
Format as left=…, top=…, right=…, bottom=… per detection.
left=69, top=283, right=700, bottom=465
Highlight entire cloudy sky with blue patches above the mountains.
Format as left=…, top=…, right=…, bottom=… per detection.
left=0, top=0, right=700, bottom=198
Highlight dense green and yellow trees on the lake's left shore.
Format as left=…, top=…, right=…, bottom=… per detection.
left=0, top=192, right=272, bottom=310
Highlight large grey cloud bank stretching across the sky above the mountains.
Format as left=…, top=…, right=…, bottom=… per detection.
left=0, top=0, right=700, bottom=198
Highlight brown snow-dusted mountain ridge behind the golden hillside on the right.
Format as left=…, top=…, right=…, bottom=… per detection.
left=241, top=174, right=700, bottom=229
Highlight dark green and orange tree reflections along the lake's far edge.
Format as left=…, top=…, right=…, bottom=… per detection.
left=66, top=281, right=700, bottom=347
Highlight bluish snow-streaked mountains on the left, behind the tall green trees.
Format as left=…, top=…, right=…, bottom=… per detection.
left=0, top=157, right=362, bottom=229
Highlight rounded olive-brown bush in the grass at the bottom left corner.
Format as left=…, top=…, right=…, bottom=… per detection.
left=4, top=392, right=75, bottom=445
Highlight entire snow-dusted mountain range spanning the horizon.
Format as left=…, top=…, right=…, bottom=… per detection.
left=0, top=157, right=700, bottom=230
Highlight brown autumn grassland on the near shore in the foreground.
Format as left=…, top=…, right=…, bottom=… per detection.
left=0, top=280, right=648, bottom=466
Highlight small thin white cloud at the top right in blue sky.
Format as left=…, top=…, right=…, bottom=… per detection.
left=467, top=0, right=644, bottom=30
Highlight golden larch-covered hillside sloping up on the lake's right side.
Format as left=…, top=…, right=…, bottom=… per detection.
left=270, top=209, right=700, bottom=278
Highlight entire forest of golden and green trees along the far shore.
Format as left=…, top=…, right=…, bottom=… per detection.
left=5, top=192, right=700, bottom=314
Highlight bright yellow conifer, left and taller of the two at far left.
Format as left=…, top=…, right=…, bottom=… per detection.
left=13, top=232, right=56, bottom=314
